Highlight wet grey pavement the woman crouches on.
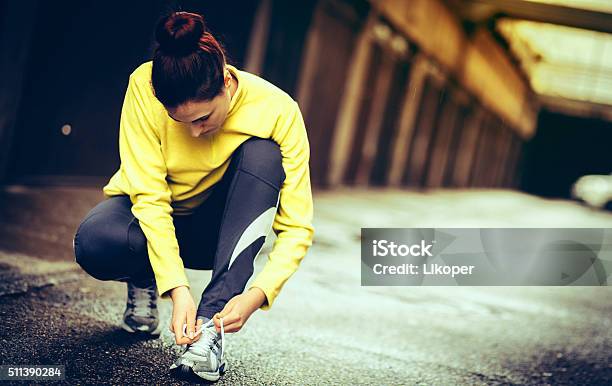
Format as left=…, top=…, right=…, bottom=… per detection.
left=0, top=187, right=612, bottom=385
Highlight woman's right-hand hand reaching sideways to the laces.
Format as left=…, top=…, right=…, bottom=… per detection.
left=213, top=287, right=266, bottom=332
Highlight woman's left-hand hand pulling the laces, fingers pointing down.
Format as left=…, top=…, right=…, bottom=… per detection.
left=170, top=286, right=202, bottom=344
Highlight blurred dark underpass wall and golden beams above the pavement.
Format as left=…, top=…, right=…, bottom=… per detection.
left=0, top=0, right=612, bottom=198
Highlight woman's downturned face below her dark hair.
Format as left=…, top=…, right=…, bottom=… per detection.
left=167, top=69, right=233, bottom=137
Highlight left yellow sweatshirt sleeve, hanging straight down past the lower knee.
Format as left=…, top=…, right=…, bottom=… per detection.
left=119, top=76, right=189, bottom=298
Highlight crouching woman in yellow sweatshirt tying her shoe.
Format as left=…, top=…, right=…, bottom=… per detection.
left=75, top=12, right=314, bottom=381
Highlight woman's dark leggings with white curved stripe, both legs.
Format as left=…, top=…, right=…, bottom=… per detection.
left=74, top=137, right=285, bottom=319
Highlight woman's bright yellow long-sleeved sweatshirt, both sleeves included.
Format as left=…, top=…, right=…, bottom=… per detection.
left=103, top=62, right=314, bottom=310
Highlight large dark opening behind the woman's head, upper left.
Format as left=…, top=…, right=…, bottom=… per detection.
left=7, top=0, right=257, bottom=184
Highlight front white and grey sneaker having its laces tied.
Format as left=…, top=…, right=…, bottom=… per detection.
left=170, top=319, right=228, bottom=382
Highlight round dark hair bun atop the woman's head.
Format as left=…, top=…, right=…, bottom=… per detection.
left=155, top=12, right=206, bottom=56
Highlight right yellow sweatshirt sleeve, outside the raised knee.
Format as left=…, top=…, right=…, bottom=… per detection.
left=249, top=100, right=314, bottom=310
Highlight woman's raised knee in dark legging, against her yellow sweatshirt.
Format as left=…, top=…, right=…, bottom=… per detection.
left=237, top=137, right=285, bottom=188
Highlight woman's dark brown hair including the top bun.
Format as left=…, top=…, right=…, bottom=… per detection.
left=151, top=12, right=225, bottom=107
